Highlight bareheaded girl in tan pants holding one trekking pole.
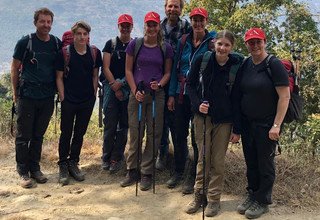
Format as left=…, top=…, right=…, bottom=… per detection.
left=185, top=30, right=244, bottom=217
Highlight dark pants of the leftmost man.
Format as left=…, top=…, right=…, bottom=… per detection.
left=15, top=97, right=54, bottom=175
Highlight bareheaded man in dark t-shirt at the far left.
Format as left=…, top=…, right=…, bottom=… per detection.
left=11, top=8, right=61, bottom=188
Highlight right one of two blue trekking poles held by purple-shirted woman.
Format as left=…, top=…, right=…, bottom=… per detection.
left=151, top=79, right=156, bottom=194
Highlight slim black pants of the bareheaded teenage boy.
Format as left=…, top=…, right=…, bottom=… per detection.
left=58, top=97, right=95, bottom=164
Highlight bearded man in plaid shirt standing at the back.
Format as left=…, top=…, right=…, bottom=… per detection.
left=156, top=0, right=191, bottom=170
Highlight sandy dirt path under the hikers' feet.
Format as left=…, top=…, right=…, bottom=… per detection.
left=0, top=145, right=320, bottom=220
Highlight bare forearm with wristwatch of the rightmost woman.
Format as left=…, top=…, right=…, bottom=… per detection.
left=269, top=86, right=290, bottom=140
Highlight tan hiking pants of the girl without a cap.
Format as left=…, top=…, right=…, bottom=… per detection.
left=193, top=114, right=232, bottom=202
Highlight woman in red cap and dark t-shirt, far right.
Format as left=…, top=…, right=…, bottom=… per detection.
left=233, top=28, right=290, bottom=219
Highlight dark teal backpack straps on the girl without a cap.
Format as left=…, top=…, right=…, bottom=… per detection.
left=199, top=50, right=244, bottom=97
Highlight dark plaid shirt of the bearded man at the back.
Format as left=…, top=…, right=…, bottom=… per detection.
left=161, top=18, right=191, bottom=54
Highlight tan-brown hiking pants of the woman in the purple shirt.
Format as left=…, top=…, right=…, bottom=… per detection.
left=126, top=89, right=164, bottom=175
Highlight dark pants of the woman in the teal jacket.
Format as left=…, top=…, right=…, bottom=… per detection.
left=174, top=95, right=198, bottom=176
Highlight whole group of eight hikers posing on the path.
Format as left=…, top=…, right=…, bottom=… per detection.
left=11, top=0, right=290, bottom=219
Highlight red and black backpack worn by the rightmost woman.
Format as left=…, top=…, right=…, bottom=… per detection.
left=266, top=55, right=304, bottom=123
